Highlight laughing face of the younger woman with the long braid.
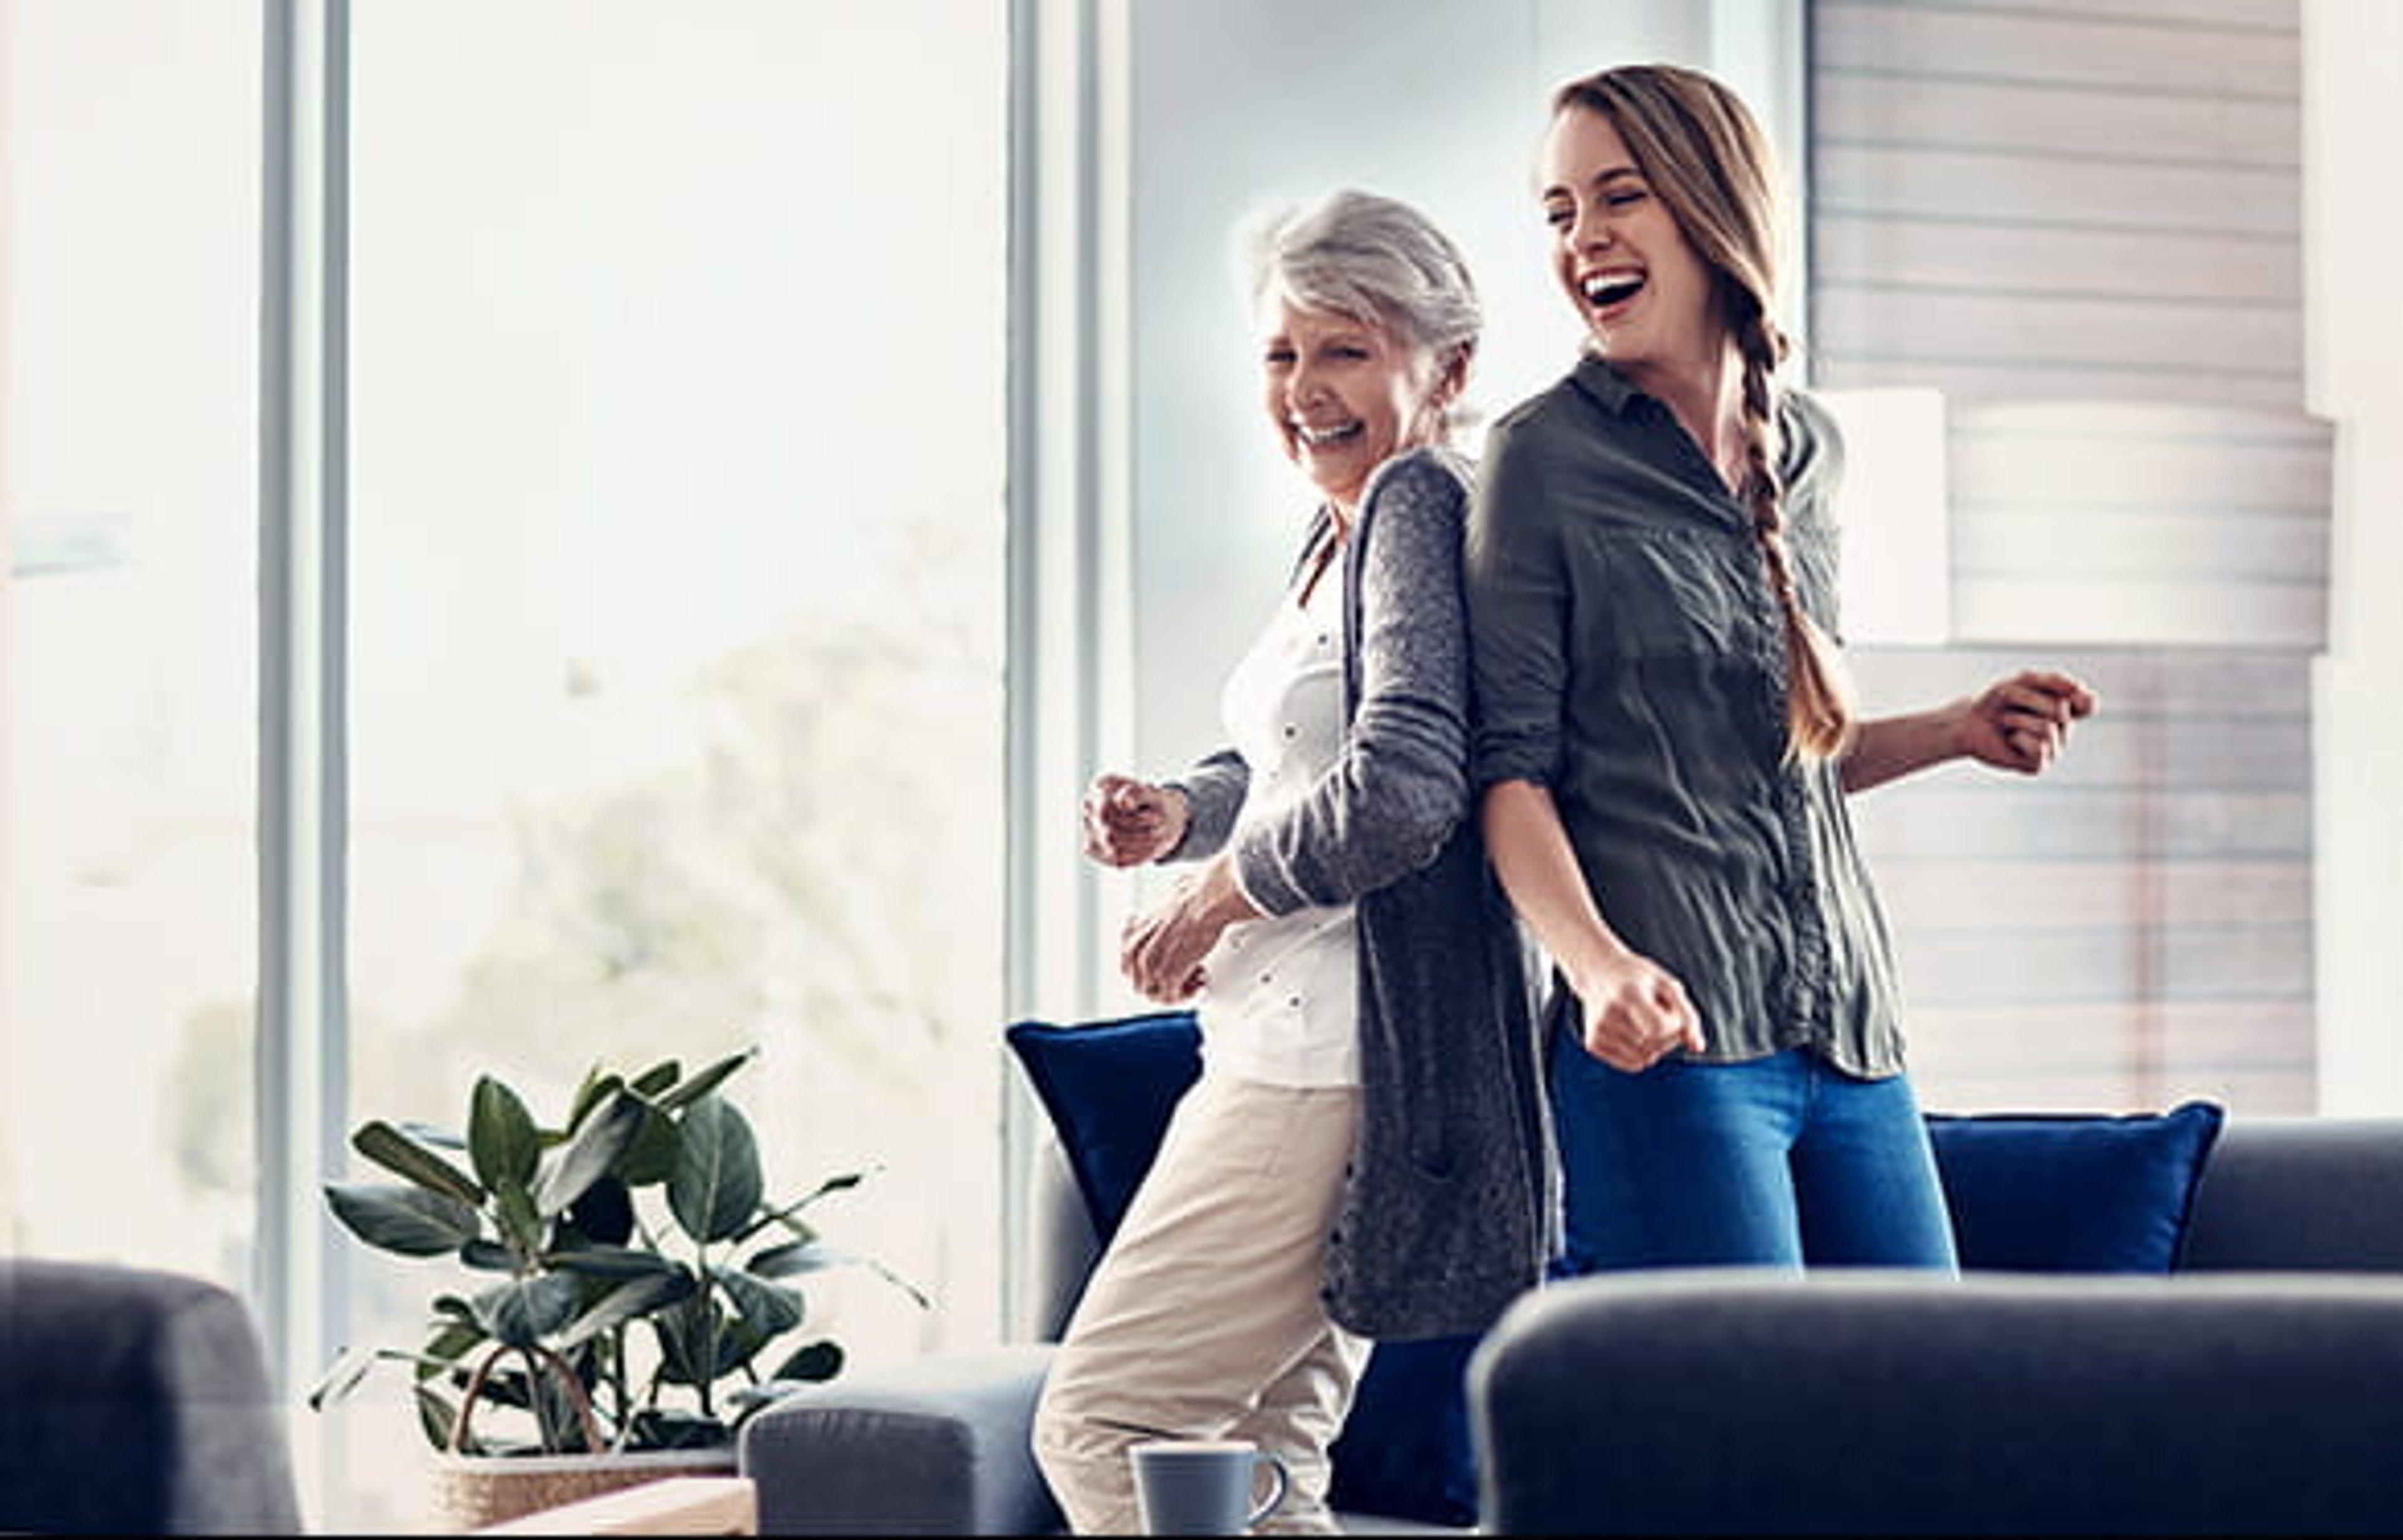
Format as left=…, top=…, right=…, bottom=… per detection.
left=1538, top=106, right=1720, bottom=370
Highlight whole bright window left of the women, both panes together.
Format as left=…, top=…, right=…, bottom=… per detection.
left=0, top=0, right=1009, bottom=1531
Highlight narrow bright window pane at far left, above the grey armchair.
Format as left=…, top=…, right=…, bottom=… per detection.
left=0, top=0, right=260, bottom=1285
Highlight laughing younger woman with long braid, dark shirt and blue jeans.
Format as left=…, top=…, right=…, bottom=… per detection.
left=1466, top=65, right=2095, bottom=1268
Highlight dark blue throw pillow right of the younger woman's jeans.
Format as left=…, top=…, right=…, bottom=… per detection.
left=1927, top=1100, right=2223, bottom=1273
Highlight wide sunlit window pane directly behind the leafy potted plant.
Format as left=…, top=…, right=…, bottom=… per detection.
left=329, top=0, right=1007, bottom=1523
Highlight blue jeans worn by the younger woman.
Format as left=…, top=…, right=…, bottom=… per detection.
left=1553, top=1031, right=1959, bottom=1273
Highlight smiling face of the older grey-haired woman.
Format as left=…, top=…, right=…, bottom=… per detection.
left=1259, top=303, right=1444, bottom=512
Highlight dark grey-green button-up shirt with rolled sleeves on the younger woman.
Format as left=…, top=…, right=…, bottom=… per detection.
left=1464, top=355, right=1903, bottom=1076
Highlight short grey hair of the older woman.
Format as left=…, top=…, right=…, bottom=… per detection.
left=1242, top=187, right=1485, bottom=370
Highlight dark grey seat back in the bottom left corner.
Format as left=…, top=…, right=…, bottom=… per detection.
left=0, top=1259, right=300, bottom=1535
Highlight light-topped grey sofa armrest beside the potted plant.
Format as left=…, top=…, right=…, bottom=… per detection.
left=740, top=1343, right=1062, bottom=1535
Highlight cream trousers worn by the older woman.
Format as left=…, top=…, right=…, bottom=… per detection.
left=1033, top=1074, right=1370, bottom=1535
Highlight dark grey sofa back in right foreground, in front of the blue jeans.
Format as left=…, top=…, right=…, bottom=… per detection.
left=1468, top=1271, right=2403, bottom=1535
